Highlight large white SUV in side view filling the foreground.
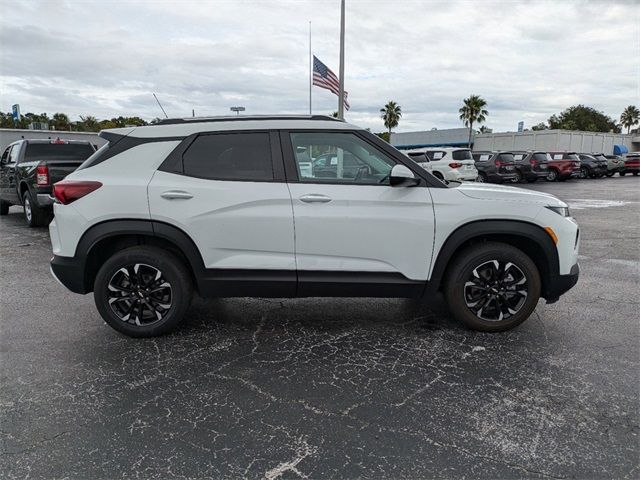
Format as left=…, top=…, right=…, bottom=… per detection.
left=50, top=116, right=579, bottom=337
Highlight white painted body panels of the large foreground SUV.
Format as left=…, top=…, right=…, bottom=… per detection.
left=50, top=119, right=579, bottom=280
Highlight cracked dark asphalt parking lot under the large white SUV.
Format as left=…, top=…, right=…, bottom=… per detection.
left=0, top=177, right=640, bottom=479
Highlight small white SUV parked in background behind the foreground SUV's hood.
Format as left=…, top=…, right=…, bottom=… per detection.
left=404, top=147, right=478, bottom=182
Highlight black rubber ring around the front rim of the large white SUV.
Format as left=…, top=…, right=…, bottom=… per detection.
left=445, top=243, right=541, bottom=332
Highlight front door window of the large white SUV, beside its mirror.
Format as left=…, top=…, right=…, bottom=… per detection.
left=290, top=132, right=395, bottom=185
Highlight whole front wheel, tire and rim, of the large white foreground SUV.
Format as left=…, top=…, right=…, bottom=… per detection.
left=444, top=242, right=541, bottom=332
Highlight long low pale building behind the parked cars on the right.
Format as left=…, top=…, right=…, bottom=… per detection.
left=391, top=128, right=640, bottom=155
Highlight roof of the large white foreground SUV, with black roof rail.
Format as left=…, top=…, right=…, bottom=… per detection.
left=104, top=115, right=361, bottom=138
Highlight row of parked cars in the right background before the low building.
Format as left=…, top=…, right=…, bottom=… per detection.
left=405, top=147, right=640, bottom=183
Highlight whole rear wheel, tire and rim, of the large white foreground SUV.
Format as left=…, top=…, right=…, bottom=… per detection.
left=93, top=246, right=193, bottom=338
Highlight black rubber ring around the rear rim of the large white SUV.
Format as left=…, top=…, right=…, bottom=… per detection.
left=93, top=247, right=193, bottom=337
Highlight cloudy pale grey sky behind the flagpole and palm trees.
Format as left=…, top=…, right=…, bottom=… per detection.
left=0, top=0, right=640, bottom=131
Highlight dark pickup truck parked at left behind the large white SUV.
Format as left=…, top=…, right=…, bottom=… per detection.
left=0, top=139, right=95, bottom=227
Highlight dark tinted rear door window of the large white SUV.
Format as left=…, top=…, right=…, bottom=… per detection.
left=182, top=132, right=273, bottom=182
